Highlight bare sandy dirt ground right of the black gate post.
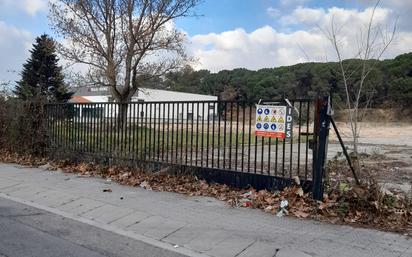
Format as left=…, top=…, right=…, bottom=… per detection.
left=328, top=122, right=412, bottom=196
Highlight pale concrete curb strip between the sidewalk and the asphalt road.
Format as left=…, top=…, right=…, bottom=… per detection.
left=0, top=193, right=210, bottom=257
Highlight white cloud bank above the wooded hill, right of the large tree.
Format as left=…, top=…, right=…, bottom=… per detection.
left=190, top=7, right=412, bottom=71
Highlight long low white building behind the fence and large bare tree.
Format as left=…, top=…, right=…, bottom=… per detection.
left=69, top=87, right=218, bottom=120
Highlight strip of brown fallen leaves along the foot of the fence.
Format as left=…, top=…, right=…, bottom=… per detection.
left=0, top=152, right=412, bottom=237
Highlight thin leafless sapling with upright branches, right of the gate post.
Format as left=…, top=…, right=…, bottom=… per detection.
left=320, top=0, right=397, bottom=172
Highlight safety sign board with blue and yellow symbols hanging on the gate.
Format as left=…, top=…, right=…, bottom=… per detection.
left=255, top=105, right=292, bottom=138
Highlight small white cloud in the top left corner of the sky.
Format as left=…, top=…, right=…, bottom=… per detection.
left=0, top=0, right=49, bottom=16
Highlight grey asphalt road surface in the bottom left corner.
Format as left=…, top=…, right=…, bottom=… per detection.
left=0, top=198, right=187, bottom=257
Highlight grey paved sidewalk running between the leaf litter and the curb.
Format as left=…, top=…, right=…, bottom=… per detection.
left=0, top=164, right=412, bottom=257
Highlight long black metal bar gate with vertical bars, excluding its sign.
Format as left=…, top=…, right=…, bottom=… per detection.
left=46, top=100, right=316, bottom=190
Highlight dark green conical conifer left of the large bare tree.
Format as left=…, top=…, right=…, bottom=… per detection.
left=14, top=34, right=72, bottom=102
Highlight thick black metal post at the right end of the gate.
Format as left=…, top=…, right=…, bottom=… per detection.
left=312, top=96, right=330, bottom=200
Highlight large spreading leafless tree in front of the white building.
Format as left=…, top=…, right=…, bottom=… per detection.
left=49, top=0, right=199, bottom=123
